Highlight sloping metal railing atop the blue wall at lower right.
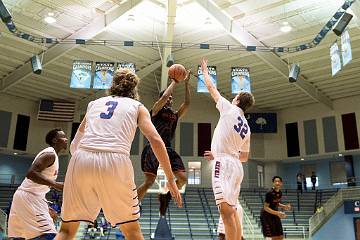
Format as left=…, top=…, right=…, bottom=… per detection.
left=309, top=187, right=360, bottom=236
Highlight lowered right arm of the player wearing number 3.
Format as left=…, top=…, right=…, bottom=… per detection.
left=138, top=106, right=182, bottom=207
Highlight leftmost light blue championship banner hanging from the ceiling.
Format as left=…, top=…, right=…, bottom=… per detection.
left=70, top=60, right=92, bottom=88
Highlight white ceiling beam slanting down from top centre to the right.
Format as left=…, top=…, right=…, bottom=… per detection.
left=196, top=0, right=333, bottom=109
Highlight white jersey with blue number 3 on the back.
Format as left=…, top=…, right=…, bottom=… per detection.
left=79, top=96, right=142, bottom=155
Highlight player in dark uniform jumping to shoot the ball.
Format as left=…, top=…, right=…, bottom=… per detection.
left=138, top=71, right=190, bottom=216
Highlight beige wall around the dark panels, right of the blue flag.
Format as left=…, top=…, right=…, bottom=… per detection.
left=264, top=96, right=360, bottom=160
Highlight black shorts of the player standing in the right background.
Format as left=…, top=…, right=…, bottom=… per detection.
left=260, top=210, right=284, bottom=237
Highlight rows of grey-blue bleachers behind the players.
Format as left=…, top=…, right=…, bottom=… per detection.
left=0, top=185, right=336, bottom=240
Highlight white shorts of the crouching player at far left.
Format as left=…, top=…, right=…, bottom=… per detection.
left=8, top=190, right=56, bottom=239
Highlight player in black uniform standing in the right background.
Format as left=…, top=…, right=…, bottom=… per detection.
left=260, top=176, right=291, bottom=240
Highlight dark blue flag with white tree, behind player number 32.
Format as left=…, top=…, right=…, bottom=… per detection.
left=245, top=113, right=277, bottom=133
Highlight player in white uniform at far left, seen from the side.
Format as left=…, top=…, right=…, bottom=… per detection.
left=8, top=128, right=67, bottom=239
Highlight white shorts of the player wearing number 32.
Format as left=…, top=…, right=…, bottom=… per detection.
left=212, top=154, right=244, bottom=208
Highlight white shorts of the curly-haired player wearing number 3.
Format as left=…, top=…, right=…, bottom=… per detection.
left=61, top=148, right=140, bottom=226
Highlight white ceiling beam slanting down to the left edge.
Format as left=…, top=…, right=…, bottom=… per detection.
left=0, top=0, right=141, bottom=92
